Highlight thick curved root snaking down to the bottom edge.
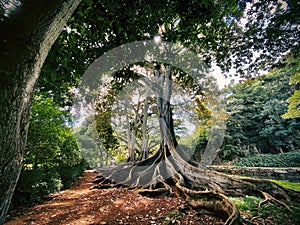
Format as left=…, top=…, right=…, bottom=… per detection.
left=176, top=182, right=241, bottom=225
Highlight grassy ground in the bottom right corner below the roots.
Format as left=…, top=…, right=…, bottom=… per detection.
left=230, top=196, right=300, bottom=225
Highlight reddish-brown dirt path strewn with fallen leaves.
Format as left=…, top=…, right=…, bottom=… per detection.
left=5, top=170, right=222, bottom=225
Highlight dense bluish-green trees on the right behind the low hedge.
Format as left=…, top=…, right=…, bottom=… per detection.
left=220, top=60, right=300, bottom=156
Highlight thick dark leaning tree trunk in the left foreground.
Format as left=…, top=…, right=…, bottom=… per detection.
left=0, top=0, right=80, bottom=224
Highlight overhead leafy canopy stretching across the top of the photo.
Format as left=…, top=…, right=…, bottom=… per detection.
left=34, top=0, right=299, bottom=105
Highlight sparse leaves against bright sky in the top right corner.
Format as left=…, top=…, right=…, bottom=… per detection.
left=225, top=0, right=300, bottom=78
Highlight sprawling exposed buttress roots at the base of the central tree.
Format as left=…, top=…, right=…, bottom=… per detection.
left=96, top=140, right=300, bottom=225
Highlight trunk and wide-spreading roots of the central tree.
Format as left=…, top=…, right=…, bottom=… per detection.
left=98, top=63, right=300, bottom=224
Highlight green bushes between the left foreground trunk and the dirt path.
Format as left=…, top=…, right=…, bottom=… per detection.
left=13, top=96, right=88, bottom=205
